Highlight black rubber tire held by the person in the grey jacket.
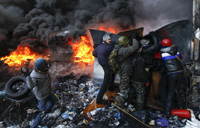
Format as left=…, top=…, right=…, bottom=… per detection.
left=5, top=76, right=30, bottom=100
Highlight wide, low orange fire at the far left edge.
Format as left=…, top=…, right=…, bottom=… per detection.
left=0, top=45, right=48, bottom=67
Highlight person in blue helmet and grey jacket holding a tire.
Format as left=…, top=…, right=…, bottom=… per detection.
left=26, top=58, right=57, bottom=128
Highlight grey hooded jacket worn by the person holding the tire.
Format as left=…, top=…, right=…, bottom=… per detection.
left=27, top=70, right=52, bottom=100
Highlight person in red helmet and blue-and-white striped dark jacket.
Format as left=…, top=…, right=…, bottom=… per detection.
left=160, top=39, right=184, bottom=117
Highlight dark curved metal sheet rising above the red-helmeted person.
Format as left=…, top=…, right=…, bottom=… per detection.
left=154, top=20, right=192, bottom=63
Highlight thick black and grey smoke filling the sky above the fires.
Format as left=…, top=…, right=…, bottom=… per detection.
left=0, top=0, right=192, bottom=42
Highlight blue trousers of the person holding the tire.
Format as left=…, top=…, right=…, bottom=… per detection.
left=31, top=94, right=58, bottom=128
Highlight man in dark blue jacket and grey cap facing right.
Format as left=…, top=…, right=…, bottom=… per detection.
left=93, top=34, right=114, bottom=104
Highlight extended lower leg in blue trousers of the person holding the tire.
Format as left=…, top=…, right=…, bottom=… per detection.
left=31, top=99, right=47, bottom=128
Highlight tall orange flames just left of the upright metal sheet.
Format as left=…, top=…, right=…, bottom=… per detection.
left=71, top=36, right=94, bottom=64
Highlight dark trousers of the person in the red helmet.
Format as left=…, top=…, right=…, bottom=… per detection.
left=165, top=73, right=183, bottom=115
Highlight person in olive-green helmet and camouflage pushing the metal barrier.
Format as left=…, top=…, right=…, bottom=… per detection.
left=115, top=36, right=139, bottom=107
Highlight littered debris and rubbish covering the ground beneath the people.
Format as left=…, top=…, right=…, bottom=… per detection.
left=0, top=74, right=200, bottom=128
